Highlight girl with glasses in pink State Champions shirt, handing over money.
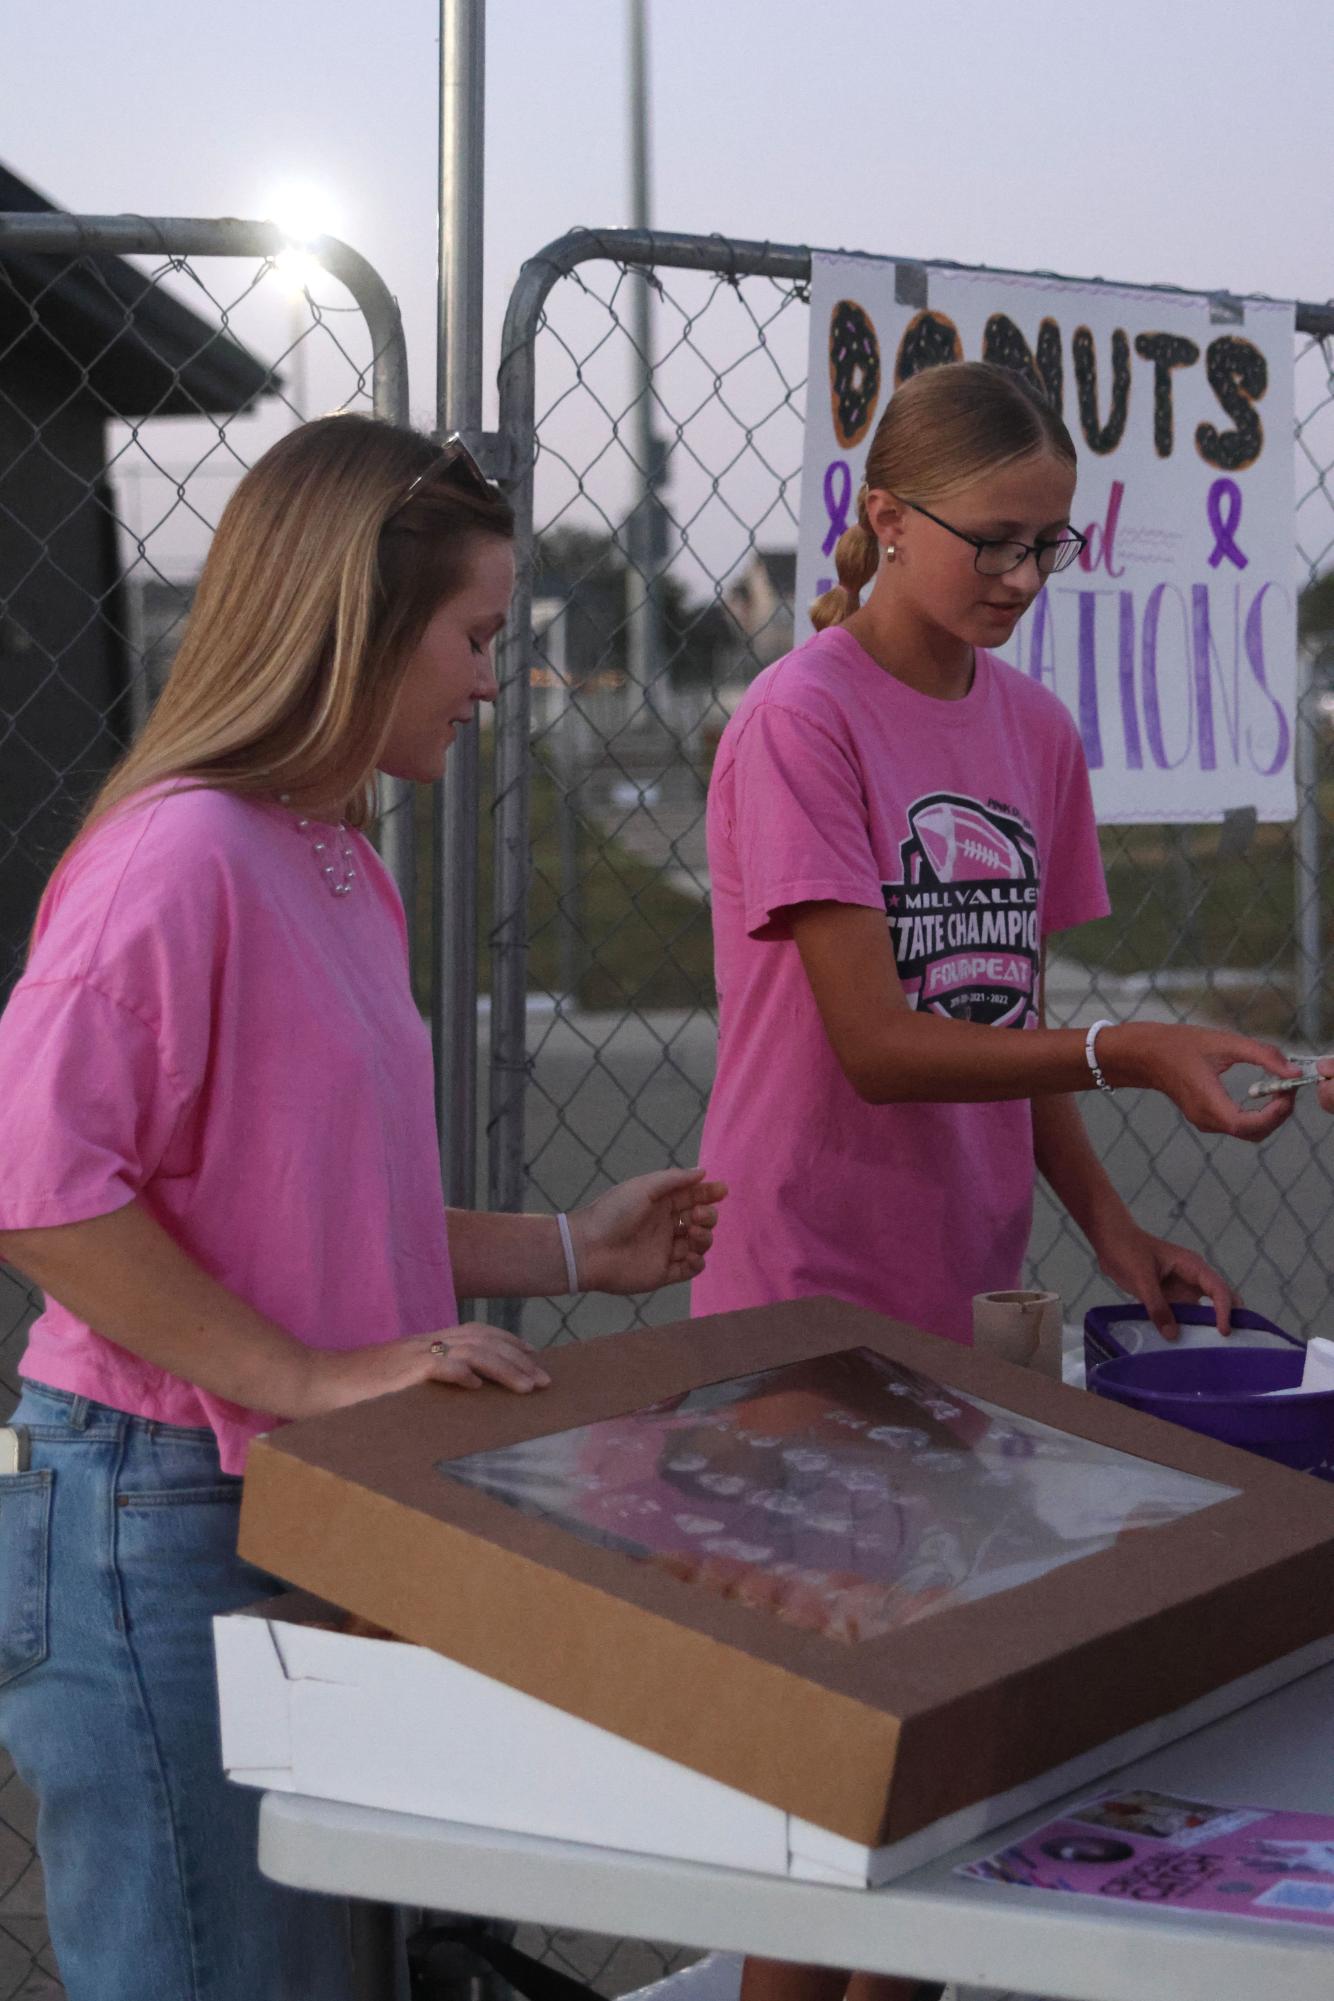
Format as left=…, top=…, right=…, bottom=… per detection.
left=692, top=364, right=1304, bottom=2001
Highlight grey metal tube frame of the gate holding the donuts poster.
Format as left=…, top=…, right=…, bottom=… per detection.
left=480, top=219, right=1334, bottom=1224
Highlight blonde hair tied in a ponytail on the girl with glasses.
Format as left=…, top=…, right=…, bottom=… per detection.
left=810, top=362, right=1076, bottom=632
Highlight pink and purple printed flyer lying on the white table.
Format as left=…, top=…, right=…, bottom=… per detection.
left=958, top=1791, right=1334, bottom=1925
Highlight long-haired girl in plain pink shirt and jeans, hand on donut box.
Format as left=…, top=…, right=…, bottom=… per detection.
left=0, top=416, right=724, bottom=2001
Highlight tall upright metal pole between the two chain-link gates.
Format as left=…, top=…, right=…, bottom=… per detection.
left=432, top=0, right=486, bottom=1209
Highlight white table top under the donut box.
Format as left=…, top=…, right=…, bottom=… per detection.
left=260, top=1667, right=1334, bottom=2001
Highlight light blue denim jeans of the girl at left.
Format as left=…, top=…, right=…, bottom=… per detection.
left=0, top=1383, right=348, bottom=2001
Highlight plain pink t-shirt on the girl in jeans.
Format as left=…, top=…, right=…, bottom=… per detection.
left=0, top=788, right=458, bottom=1473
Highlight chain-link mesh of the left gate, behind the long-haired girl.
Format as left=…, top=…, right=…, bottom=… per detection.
left=0, top=207, right=412, bottom=2001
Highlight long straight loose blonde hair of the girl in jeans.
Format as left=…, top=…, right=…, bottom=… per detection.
left=76, top=416, right=514, bottom=842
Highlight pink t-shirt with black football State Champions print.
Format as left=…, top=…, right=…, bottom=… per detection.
left=692, top=626, right=1108, bottom=1343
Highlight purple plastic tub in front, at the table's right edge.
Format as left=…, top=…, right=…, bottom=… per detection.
left=1088, top=1307, right=1334, bottom=1481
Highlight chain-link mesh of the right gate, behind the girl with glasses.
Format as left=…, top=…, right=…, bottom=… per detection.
left=488, top=232, right=1334, bottom=1343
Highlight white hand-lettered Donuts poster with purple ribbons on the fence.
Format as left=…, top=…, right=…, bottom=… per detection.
left=796, top=254, right=1296, bottom=822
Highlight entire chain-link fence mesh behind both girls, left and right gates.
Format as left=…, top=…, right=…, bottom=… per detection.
left=0, top=214, right=1334, bottom=2001
